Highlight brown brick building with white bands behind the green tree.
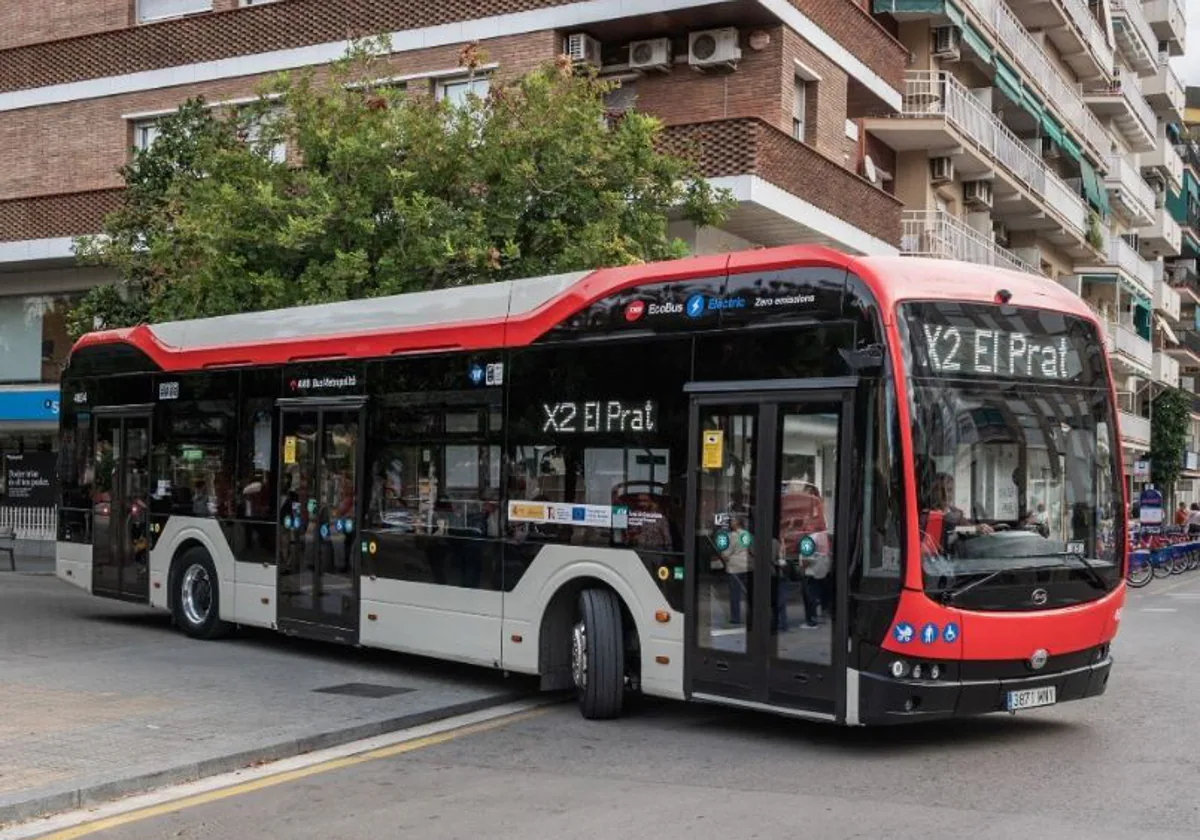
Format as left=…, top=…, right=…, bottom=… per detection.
left=0, top=0, right=908, bottom=465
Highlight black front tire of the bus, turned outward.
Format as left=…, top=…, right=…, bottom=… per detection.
left=571, top=589, right=625, bottom=720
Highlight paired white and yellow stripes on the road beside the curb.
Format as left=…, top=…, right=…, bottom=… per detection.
left=7, top=700, right=557, bottom=840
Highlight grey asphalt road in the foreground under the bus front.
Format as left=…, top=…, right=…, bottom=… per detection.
left=23, top=574, right=1200, bottom=840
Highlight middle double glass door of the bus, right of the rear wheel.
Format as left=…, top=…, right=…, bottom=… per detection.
left=276, top=407, right=362, bottom=642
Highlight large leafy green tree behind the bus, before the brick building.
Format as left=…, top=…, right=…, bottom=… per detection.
left=72, top=40, right=732, bottom=332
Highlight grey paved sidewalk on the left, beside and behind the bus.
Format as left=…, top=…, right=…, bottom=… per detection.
left=0, top=573, right=536, bottom=826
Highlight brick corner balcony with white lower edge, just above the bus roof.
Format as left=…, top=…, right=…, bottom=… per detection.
left=662, top=119, right=902, bottom=253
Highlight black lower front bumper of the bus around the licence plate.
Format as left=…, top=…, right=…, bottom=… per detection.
left=858, top=655, right=1112, bottom=725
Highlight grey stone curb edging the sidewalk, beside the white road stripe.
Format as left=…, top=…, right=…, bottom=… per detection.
left=0, top=692, right=528, bottom=829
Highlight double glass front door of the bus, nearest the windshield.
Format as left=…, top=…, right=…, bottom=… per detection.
left=685, top=389, right=853, bottom=720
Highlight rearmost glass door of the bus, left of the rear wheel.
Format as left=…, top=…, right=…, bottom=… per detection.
left=91, top=414, right=150, bottom=601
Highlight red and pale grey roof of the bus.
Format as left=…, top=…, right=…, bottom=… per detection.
left=72, top=246, right=1094, bottom=371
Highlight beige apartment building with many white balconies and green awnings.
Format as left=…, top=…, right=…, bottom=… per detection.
left=864, top=0, right=1200, bottom=499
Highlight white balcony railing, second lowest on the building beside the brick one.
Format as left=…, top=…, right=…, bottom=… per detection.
left=900, top=70, right=1087, bottom=234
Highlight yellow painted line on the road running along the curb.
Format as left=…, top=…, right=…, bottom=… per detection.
left=38, top=707, right=548, bottom=840
